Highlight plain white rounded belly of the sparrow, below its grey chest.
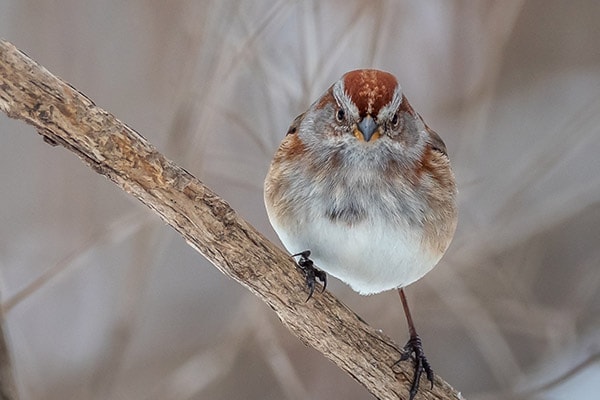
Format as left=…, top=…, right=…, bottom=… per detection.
left=272, top=214, right=441, bottom=294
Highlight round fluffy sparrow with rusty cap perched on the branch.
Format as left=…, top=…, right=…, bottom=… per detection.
left=264, top=69, right=458, bottom=400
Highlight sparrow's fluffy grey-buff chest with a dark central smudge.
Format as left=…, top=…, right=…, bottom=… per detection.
left=286, top=145, right=423, bottom=226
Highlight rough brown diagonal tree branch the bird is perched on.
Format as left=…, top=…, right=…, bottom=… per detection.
left=0, top=41, right=461, bottom=399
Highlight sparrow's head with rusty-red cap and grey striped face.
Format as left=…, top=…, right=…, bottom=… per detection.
left=299, top=69, right=445, bottom=159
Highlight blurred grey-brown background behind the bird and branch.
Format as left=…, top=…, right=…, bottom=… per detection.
left=0, top=0, right=600, bottom=400
